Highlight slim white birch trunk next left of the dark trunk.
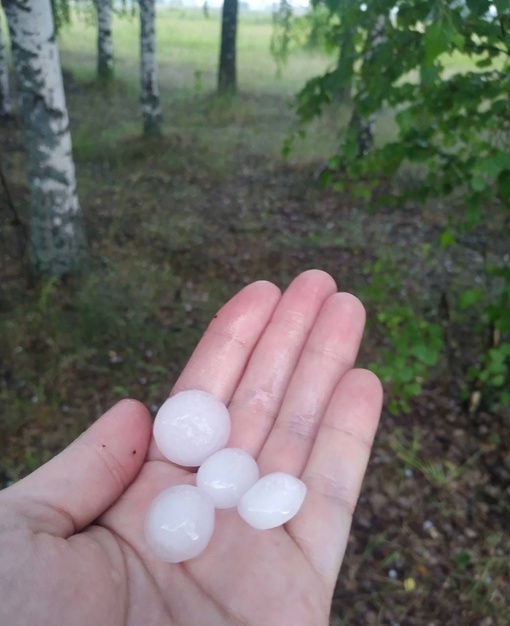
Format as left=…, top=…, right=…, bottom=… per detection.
left=139, top=0, right=161, bottom=137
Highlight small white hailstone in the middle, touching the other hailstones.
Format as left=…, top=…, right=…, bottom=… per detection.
left=197, top=448, right=259, bottom=509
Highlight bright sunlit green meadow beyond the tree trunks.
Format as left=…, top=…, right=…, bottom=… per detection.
left=59, top=9, right=328, bottom=97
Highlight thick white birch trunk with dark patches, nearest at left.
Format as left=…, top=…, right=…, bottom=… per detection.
left=2, top=0, right=87, bottom=276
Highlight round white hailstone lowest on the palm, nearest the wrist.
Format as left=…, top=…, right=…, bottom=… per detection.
left=145, top=485, right=214, bottom=563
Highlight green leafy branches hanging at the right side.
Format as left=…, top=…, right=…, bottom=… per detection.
left=273, top=0, right=510, bottom=412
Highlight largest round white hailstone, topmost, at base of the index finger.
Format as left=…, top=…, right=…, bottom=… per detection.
left=154, top=391, right=230, bottom=467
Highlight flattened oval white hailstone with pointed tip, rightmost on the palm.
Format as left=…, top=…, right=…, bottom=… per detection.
left=237, top=472, right=306, bottom=530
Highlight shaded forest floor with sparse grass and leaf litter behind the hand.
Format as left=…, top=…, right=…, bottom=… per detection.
left=0, top=7, right=510, bottom=626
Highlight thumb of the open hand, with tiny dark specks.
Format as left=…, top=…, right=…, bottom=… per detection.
left=0, top=400, right=151, bottom=538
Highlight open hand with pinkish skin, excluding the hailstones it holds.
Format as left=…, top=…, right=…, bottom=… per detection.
left=0, top=270, right=382, bottom=626
